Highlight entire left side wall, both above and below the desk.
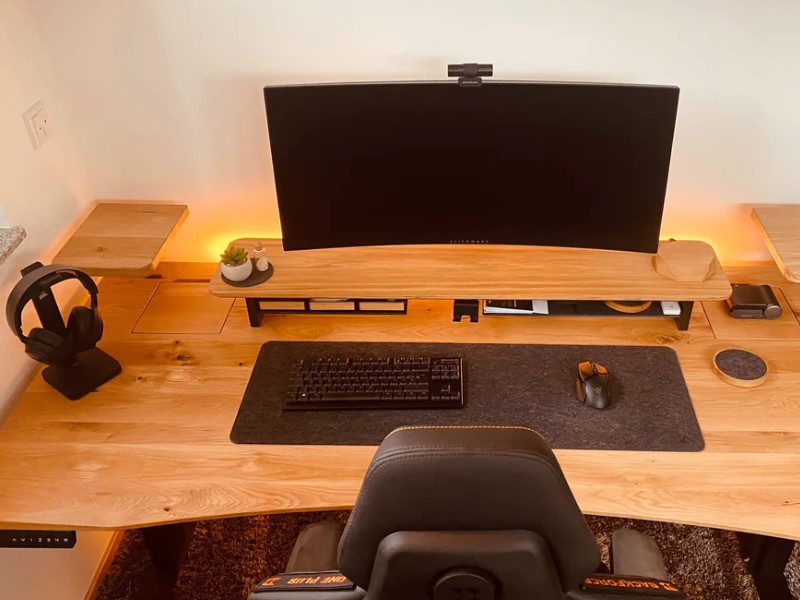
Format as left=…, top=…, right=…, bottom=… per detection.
left=0, top=0, right=110, bottom=600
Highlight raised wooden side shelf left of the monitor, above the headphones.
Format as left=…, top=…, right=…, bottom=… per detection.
left=53, top=202, right=189, bottom=277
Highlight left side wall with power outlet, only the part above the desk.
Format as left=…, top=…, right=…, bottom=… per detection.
left=0, top=0, right=91, bottom=414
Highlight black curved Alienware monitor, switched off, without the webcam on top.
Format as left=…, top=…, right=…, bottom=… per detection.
left=264, top=81, right=678, bottom=252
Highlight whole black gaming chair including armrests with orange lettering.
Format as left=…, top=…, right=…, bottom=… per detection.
left=249, top=427, right=685, bottom=600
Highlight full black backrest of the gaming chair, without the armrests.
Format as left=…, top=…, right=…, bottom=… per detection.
left=338, top=427, right=600, bottom=600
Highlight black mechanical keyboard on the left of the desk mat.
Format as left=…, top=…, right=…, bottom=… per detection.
left=283, top=356, right=464, bottom=410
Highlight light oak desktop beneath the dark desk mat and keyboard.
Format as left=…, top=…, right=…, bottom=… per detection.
left=0, top=265, right=800, bottom=539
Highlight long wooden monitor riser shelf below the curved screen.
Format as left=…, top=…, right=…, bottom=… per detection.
left=210, top=238, right=731, bottom=300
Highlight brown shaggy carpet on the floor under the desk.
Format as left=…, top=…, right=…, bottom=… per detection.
left=96, top=511, right=800, bottom=600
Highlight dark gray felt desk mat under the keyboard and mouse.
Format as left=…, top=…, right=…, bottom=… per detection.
left=231, top=342, right=704, bottom=452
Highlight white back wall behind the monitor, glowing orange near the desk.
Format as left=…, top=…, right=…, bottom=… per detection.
left=35, top=0, right=800, bottom=260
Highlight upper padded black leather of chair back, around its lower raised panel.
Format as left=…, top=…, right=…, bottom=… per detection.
left=338, top=427, right=600, bottom=597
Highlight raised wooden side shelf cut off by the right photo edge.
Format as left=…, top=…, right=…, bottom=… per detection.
left=751, top=204, right=800, bottom=283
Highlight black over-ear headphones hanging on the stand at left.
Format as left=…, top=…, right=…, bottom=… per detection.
left=6, top=263, right=103, bottom=365
